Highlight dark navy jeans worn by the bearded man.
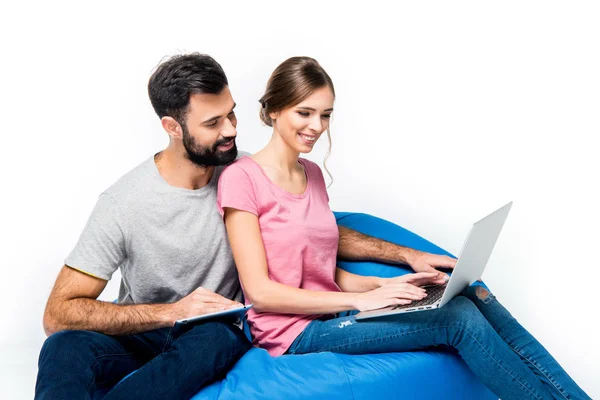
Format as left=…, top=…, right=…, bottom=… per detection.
left=35, top=322, right=251, bottom=400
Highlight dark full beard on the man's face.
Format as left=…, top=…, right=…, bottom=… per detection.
left=181, top=124, right=237, bottom=167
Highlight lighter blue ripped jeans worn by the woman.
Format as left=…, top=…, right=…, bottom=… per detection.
left=288, top=286, right=590, bottom=400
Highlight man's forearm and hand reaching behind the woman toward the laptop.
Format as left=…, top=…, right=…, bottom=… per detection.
left=338, top=226, right=456, bottom=281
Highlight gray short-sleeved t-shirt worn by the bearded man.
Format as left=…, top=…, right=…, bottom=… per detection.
left=65, top=153, right=246, bottom=304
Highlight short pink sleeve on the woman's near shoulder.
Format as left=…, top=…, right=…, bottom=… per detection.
left=217, top=163, right=258, bottom=217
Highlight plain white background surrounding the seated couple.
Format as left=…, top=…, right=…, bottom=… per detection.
left=0, top=1, right=600, bottom=399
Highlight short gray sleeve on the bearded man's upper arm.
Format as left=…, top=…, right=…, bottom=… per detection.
left=65, top=193, right=126, bottom=280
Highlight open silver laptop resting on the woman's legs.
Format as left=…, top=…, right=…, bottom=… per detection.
left=356, top=201, right=512, bottom=320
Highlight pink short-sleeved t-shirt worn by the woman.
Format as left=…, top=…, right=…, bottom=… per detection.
left=217, top=157, right=341, bottom=356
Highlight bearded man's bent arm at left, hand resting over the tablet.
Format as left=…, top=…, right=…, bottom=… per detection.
left=43, top=265, right=240, bottom=336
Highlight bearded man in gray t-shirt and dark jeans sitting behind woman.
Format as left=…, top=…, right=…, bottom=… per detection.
left=36, top=53, right=454, bottom=399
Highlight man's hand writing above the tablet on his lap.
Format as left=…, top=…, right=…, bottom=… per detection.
left=170, top=287, right=243, bottom=323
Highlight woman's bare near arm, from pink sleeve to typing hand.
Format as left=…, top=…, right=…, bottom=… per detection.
left=224, top=207, right=424, bottom=314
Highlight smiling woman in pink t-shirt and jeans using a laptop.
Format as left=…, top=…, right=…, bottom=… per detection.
left=218, top=57, right=589, bottom=399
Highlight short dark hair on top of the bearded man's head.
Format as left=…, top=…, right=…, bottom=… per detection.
left=148, top=53, right=228, bottom=126
